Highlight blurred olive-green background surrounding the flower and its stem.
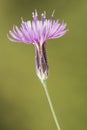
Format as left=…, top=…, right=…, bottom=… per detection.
left=0, top=0, right=87, bottom=130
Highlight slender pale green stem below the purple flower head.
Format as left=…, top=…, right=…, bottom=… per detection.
left=41, top=81, right=61, bottom=130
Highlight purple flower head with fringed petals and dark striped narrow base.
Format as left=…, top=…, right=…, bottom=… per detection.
left=8, top=10, right=68, bottom=80
